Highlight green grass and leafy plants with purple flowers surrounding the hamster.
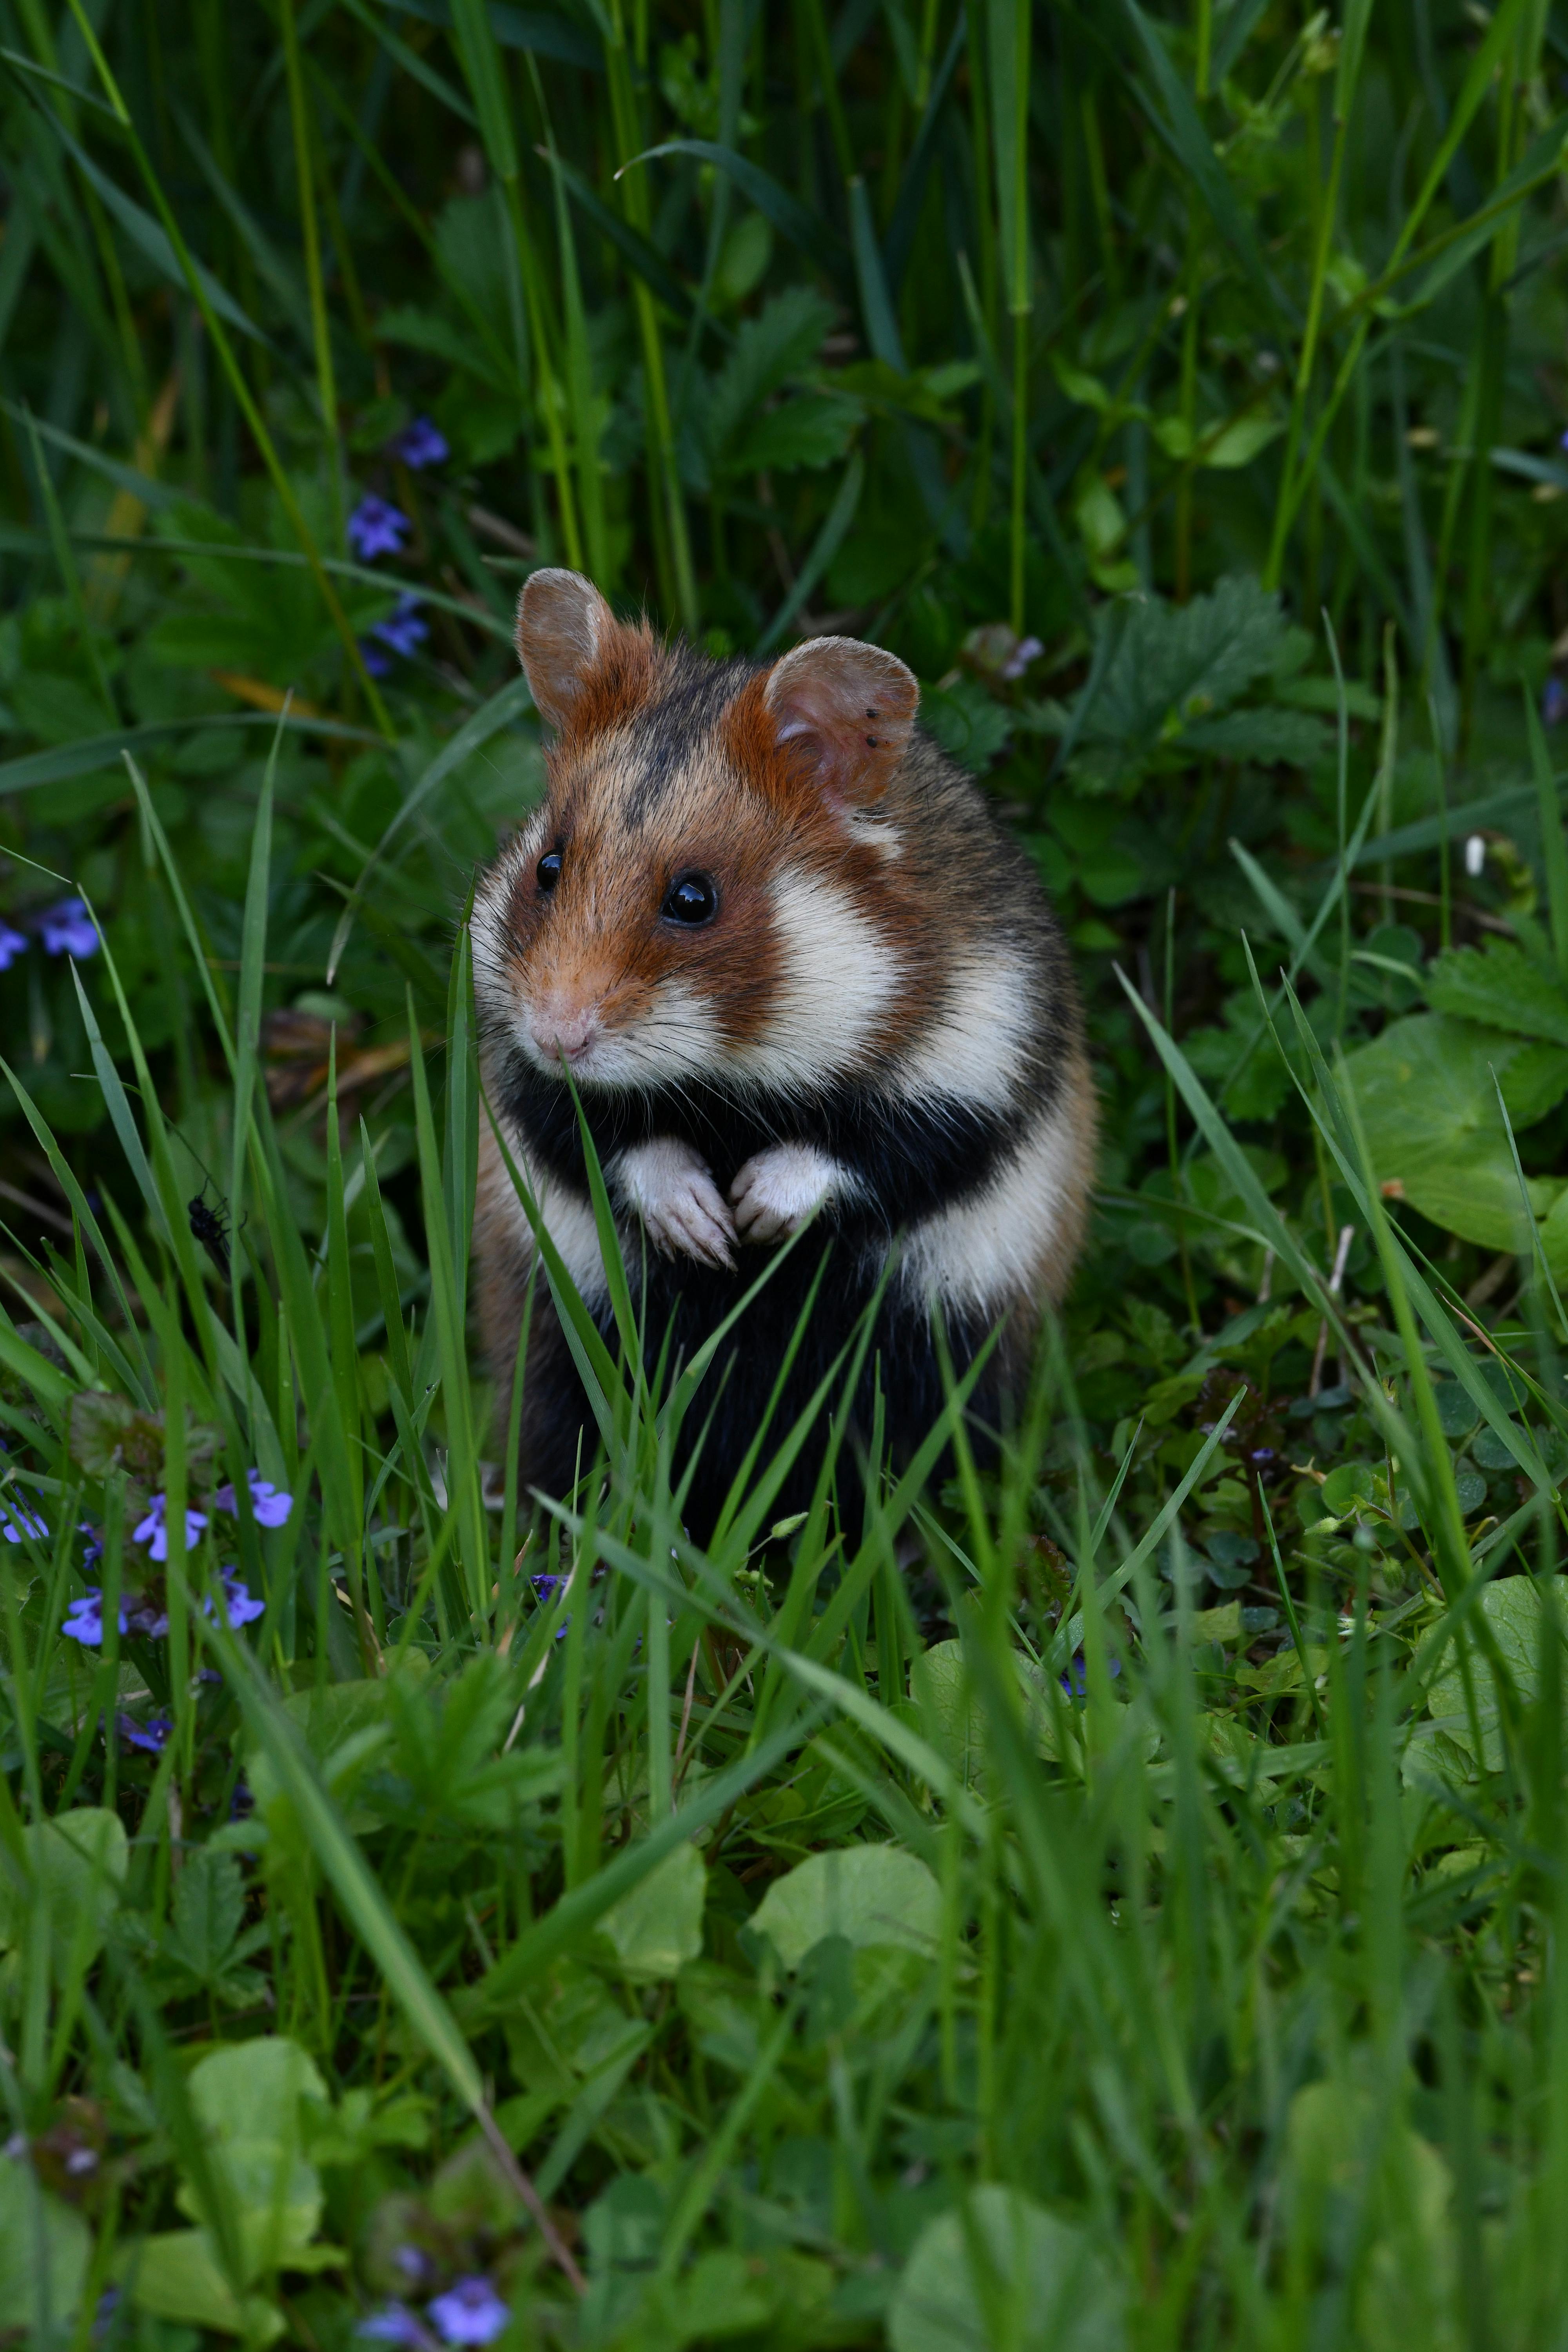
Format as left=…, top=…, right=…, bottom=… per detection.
left=0, top=0, right=1568, bottom=2352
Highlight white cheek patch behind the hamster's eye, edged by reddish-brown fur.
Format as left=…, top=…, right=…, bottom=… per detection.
left=729, top=870, right=900, bottom=1091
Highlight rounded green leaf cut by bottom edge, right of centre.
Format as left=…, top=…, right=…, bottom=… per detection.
left=889, top=2180, right=1126, bottom=2352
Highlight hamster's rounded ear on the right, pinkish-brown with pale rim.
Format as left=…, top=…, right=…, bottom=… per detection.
left=762, top=637, right=919, bottom=804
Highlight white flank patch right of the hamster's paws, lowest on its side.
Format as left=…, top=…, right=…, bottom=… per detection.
left=898, top=1103, right=1082, bottom=1317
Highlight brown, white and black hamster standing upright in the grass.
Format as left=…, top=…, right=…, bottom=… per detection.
left=472, top=569, right=1096, bottom=1541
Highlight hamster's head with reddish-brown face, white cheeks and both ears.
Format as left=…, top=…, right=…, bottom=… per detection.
left=472, top=572, right=919, bottom=1091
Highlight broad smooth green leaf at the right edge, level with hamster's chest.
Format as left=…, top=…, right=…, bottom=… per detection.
left=1345, top=1014, right=1568, bottom=1249
